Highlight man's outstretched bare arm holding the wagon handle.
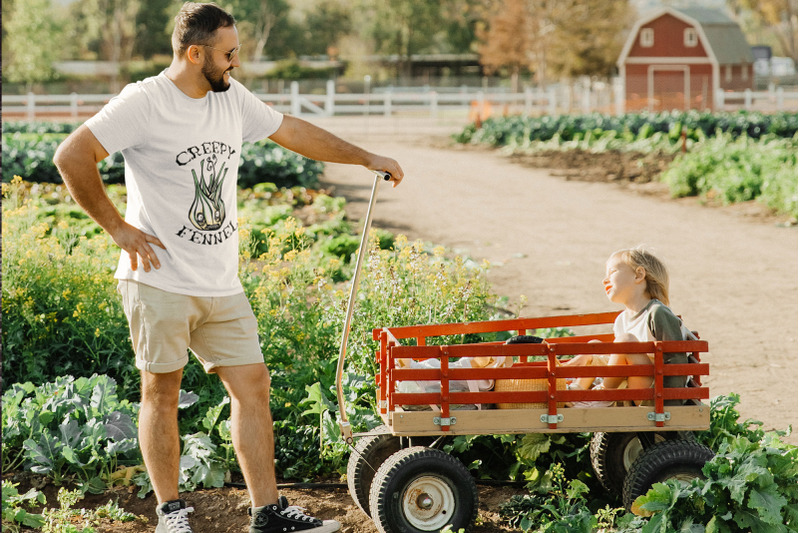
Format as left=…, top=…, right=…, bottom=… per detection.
left=270, top=115, right=403, bottom=187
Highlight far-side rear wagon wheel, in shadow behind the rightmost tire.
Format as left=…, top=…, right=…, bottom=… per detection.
left=589, top=431, right=694, bottom=496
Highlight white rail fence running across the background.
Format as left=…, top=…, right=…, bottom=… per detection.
left=2, top=80, right=797, bottom=120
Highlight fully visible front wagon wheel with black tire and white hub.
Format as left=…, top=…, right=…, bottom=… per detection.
left=369, top=446, right=478, bottom=533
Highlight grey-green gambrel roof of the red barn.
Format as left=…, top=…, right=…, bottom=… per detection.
left=618, top=7, right=754, bottom=65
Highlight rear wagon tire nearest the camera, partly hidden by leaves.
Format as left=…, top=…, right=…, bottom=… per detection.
left=622, top=439, right=714, bottom=511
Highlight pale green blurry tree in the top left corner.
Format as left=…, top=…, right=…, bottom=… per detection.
left=3, top=0, right=63, bottom=91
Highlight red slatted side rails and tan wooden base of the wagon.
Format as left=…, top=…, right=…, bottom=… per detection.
left=373, top=312, right=709, bottom=435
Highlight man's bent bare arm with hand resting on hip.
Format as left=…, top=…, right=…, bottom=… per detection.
left=53, top=125, right=164, bottom=272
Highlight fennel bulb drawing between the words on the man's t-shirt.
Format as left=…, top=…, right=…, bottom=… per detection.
left=189, top=154, right=228, bottom=231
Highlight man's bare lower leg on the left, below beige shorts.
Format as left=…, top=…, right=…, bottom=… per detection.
left=139, top=369, right=183, bottom=503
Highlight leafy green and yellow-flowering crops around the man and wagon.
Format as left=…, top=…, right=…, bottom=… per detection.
left=2, top=118, right=797, bottom=532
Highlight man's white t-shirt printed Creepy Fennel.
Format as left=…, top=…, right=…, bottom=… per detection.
left=86, top=72, right=283, bottom=296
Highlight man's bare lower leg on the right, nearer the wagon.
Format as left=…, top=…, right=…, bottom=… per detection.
left=214, top=363, right=278, bottom=507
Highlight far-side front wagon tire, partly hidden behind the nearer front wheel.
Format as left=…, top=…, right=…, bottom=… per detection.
left=347, top=426, right=401, bottom=515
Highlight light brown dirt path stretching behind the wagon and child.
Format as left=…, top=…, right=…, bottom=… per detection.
left=316, top=117, right=798, bottom=444
